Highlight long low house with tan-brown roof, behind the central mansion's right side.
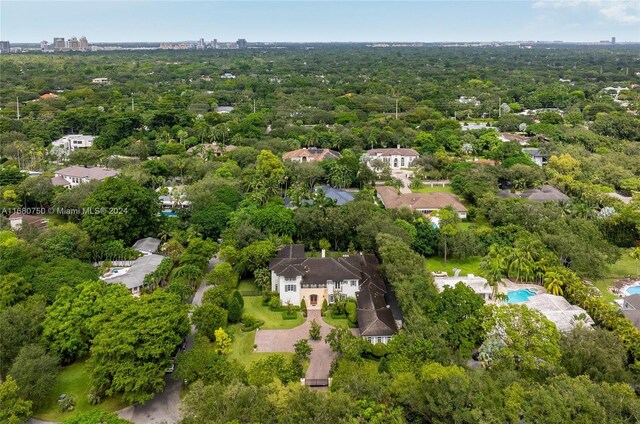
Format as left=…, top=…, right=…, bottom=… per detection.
left=376, top=186, right=467, bottom=219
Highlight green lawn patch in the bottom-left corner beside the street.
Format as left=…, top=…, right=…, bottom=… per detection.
left=34, top=361, right=127, bottom=421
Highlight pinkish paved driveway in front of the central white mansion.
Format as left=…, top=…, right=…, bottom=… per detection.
left=255, top=310, right=358, bottom=379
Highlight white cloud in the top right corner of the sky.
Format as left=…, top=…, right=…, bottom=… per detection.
left=533, top=0, right=640, bottom=24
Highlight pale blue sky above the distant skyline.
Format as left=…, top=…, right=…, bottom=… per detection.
left=0, top=0, right=640, bottom=43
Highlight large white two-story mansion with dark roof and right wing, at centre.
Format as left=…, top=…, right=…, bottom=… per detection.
left=269, top=244, right=402, bottom=344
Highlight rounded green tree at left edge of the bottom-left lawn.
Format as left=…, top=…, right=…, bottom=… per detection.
left=9, top=344, right=58, bottom=409
